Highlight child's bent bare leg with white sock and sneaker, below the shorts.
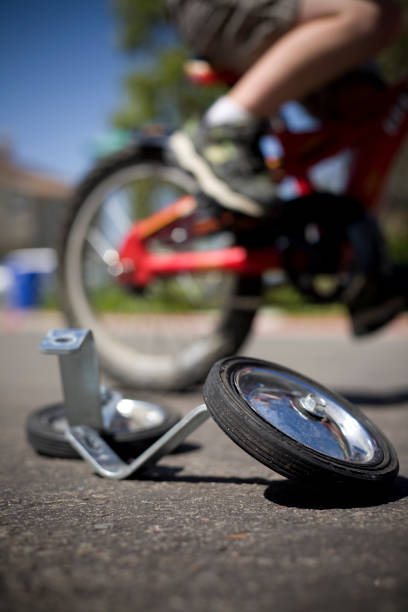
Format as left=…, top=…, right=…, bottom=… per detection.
left=171, top=0, right=400, bottom=215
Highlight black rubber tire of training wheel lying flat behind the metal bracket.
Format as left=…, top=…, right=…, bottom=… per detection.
left=26, top=404, right=179, bottom=459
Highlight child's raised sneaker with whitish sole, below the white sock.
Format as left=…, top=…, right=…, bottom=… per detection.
left=169, top=121, right=277, bottom=217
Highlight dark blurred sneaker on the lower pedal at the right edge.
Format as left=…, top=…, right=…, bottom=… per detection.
left=347, top=267, right=408, bottom=336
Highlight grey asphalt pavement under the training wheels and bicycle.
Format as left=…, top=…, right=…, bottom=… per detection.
left=0, top=316, right=408, bottom=612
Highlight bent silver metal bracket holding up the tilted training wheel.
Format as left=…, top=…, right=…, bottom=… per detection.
left=40, top=329, right=209, bottom=480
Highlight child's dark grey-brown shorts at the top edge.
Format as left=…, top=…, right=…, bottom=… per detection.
left=166, top=0, right=298, bottom=74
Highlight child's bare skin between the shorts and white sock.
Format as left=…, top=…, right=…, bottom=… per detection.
left=228, top=0, right=402, bottom=117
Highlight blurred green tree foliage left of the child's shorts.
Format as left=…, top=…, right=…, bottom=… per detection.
left=113, top=0, right=224, bottom=129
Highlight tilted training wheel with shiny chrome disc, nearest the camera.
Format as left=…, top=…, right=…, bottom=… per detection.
left=204, top=357, right=398, bottom=488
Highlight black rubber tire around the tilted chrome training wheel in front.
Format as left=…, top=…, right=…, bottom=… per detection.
left=203, top=357, right=399, bottom=491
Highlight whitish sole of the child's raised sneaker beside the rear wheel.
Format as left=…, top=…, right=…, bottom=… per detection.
left=169, top=132, right=265, bottom=217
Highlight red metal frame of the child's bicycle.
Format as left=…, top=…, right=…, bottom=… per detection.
left=119, top=73, right=408, bottom=287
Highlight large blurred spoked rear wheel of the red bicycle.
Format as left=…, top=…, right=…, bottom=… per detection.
left=59, top=146, right=261, bottom=390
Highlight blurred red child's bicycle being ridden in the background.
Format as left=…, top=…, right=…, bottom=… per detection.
left=59, top=62, right=408, bottom=390
